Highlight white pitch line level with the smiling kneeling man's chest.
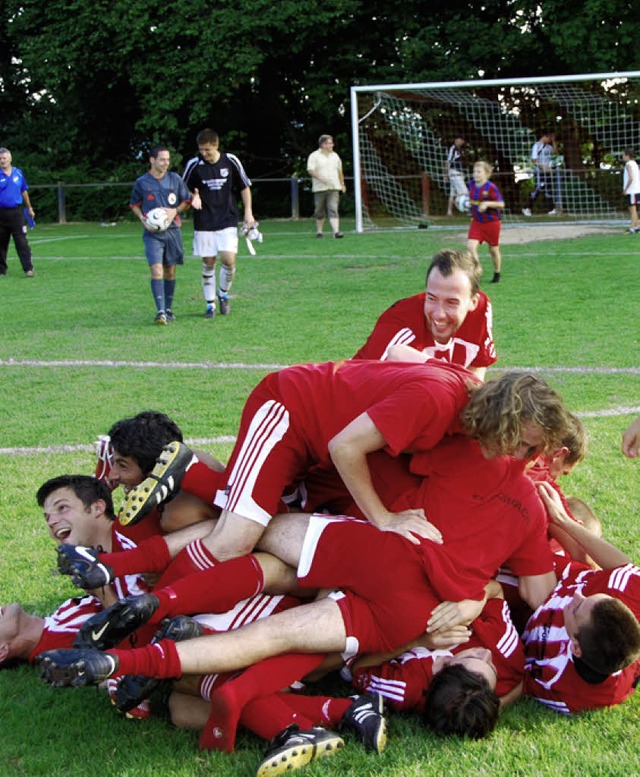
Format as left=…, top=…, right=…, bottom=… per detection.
left=0, top=359, right=640, bottom=375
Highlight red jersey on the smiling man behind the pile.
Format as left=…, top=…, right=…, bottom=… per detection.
left=353, top=291, right=498, bottom=367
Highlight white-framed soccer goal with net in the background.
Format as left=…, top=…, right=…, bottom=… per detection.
left=351, top=71, right=640, bottom=232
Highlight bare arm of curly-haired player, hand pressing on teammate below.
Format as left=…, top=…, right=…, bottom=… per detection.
left=329, top=413, right=442, bottom=545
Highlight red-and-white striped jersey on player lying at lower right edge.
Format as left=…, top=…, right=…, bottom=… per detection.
left=523, top=561, right=640, bottom=715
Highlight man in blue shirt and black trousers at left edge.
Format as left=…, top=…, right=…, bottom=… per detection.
left=0, top=148, right=35, bottom=278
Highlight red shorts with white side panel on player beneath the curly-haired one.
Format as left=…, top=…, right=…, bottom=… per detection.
left=298, top=515, right=440, bottom=657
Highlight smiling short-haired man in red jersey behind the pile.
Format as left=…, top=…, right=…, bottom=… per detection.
left=353, top=248, right=497, bottom=380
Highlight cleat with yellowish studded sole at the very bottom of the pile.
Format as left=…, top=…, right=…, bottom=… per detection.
left=256, top=723, right=344, bottom=777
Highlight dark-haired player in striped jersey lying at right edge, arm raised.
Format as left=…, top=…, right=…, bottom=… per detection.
left=523, top=483, right=640, bottom=714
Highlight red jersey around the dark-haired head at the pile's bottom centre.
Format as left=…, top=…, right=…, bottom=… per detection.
left=353, top=599, right=524, bottom=712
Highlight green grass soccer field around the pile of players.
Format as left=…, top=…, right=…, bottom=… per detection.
left=0, top=220, right=640, bottom=777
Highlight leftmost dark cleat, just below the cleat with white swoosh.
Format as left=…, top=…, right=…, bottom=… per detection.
left=36, top=648, right=119, bottom=688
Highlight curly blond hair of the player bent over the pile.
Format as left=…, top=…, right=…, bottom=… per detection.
left=460, top=372, right=569, bottom=456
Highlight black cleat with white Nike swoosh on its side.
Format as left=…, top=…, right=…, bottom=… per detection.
left=73, top=594, right=160, bottom=650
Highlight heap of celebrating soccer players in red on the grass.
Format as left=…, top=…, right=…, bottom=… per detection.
left=0, top=250, right=640, bottom=775
